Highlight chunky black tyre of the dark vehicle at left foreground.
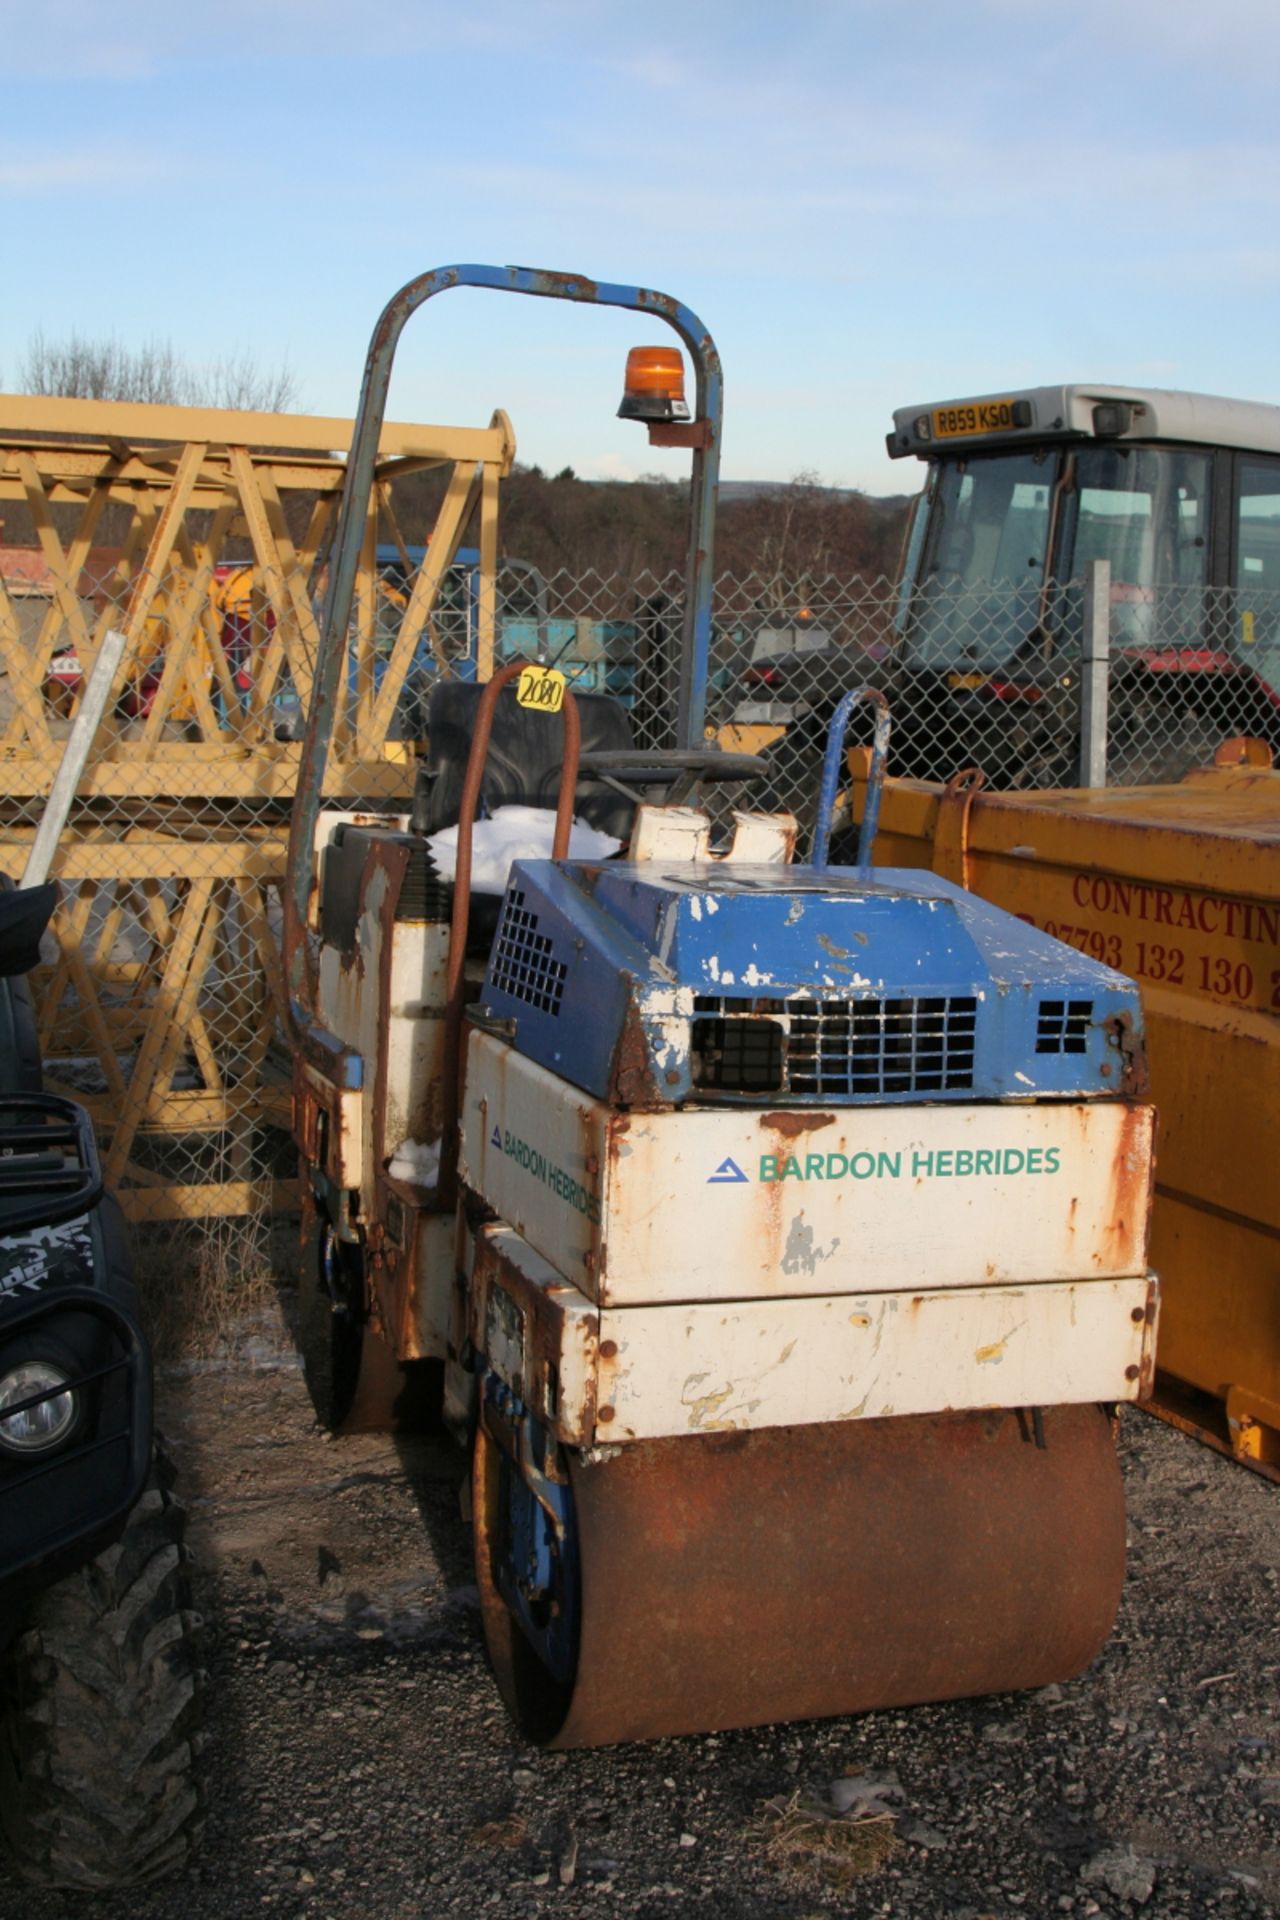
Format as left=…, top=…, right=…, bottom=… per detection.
left=0, top=1467, right=203, bottom=1887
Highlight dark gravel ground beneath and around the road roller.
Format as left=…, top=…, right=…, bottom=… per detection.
left=0, top=1336, right=1280, bottom=1920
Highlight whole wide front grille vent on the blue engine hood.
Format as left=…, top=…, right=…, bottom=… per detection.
left=693, top=995, right=977, bottom=1098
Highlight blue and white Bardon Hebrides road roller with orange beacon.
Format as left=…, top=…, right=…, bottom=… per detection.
left=284, top=267, right=1157, bottom=1747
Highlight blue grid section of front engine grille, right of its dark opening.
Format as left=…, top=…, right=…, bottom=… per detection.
left=787, top=995, right=977, bottom=1098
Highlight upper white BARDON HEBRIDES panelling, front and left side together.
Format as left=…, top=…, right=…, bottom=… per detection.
left=462, top=1033, right=1151, bottom=1306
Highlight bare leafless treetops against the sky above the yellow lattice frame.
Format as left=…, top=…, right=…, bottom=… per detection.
left=19, top=330, right=297, bottom=413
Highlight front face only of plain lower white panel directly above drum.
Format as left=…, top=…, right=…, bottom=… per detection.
left=597, top=1277, right=1155, bottom=1440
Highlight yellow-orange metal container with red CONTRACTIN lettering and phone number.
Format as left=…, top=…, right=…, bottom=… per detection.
left=856, top=766, right=1280, bottom=1476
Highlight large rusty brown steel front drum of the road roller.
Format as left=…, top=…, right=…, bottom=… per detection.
left=476, top=1405, right=1125, bottom=1747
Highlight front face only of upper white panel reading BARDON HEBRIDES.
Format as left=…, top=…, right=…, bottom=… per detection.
left=601, top=1102, right=1151, bottom=1306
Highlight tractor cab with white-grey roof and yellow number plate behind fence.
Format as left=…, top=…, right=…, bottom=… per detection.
left=889, top=386, right=1280, bottom=783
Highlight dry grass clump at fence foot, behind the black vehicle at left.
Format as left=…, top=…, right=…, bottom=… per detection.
left=132, top=1213, right=280, bottom=1365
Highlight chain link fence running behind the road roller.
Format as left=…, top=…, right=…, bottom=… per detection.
left=0, top=526, right=1280, bottom=1223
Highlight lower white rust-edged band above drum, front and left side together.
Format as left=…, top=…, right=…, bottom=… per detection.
left=468, top=1198, right=1157, bottom=1446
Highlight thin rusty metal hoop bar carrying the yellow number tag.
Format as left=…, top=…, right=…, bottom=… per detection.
left=439, top=660, right=581, bottom=1206
